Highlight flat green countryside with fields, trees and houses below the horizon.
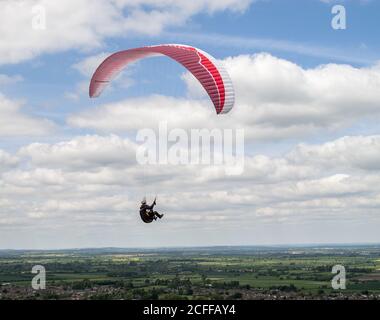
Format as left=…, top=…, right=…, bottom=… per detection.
left=0, top=245, right=380, bottom=300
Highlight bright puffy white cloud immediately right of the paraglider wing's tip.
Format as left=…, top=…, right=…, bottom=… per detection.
left=221, top=54, right=380, bottom=131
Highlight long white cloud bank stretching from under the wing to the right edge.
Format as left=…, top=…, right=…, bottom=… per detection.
left=68, top=54, right=380, bottom=140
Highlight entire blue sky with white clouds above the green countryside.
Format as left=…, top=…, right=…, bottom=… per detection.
left=0, top=0, right=380, bottom=249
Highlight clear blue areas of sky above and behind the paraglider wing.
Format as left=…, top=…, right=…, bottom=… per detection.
left=0, top=0, right=380, bottom=121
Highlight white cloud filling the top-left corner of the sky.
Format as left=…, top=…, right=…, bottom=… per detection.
left=0, top=0, right=252, bottom=64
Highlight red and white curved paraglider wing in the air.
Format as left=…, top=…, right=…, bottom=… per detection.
left=89, top=44, right=235, bottom=114
